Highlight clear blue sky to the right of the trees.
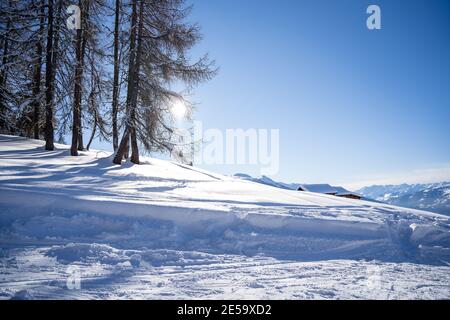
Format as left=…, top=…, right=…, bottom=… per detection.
left=89, top=0, right=450, bottom=188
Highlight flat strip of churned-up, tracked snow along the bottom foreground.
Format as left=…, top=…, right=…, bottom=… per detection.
left=0, top=244, right=450, bottom=299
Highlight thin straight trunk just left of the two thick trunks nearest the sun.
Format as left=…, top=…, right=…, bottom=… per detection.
left=112, top=0, right=120, bottom=151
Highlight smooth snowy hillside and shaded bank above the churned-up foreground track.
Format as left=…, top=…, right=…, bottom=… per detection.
left=0, top=136, right=450, bottom=262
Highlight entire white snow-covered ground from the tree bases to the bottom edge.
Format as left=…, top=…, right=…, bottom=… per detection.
left=0, top=135, right=450, bottom=299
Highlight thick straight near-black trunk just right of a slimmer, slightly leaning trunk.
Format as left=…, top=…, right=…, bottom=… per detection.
left=45, top=0, right=55, bottom=150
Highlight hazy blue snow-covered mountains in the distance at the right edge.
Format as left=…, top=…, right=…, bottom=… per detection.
left=356, top=182, right=450, bottom=215
